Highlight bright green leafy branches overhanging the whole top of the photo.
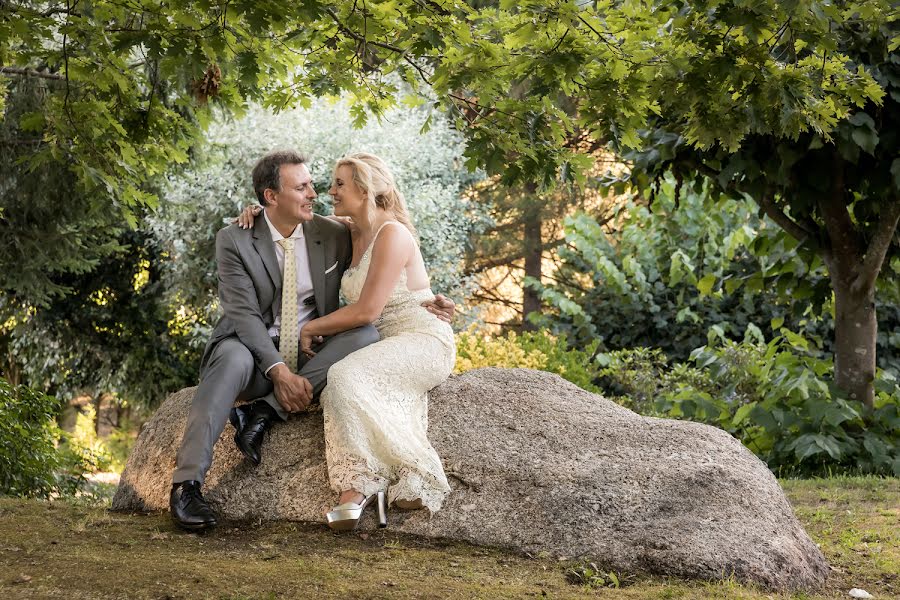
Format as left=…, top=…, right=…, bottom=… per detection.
left=0, top=0, right=897, bottom=408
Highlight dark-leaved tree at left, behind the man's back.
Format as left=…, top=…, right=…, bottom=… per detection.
left=10, top=226, right=200, bottom=417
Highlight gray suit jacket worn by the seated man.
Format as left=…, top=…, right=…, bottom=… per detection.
left=200, top=212, right=353, bottom=377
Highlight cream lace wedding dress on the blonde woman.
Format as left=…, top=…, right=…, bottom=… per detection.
left=321, top=222, right=456, bottom=512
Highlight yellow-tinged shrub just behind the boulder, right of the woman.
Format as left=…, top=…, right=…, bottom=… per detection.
left=455, top=331, right=600, bottom=392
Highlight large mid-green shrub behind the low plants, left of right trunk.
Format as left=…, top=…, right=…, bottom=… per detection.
left=527, top=179, right=900, bottom=377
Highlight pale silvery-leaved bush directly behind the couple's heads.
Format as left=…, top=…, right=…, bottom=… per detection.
left=150, top=100, right=486, bottom=344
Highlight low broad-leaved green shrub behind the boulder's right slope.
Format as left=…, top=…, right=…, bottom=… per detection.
left=599, top=328, right=900, bottom=476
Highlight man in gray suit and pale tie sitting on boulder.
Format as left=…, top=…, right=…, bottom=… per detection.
left=169, top=151, right=455, bottom=530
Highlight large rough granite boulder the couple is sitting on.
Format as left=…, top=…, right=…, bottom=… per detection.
left=113, top=369, right=828, bottom=589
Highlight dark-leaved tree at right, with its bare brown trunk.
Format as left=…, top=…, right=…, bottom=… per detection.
left=633, top=2, right=900, bottom=405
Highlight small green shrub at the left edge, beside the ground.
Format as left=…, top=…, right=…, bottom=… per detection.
left=0, top=378, right=88, bottom=498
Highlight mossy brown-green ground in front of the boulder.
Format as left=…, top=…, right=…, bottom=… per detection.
left=0, top=478, right=900, bottom=600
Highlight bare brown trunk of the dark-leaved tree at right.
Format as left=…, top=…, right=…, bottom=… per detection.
left=831, top=275, right=878, bottom=406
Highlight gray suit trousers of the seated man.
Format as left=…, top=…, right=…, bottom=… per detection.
left=172, top=325, right=379, bottom=483
